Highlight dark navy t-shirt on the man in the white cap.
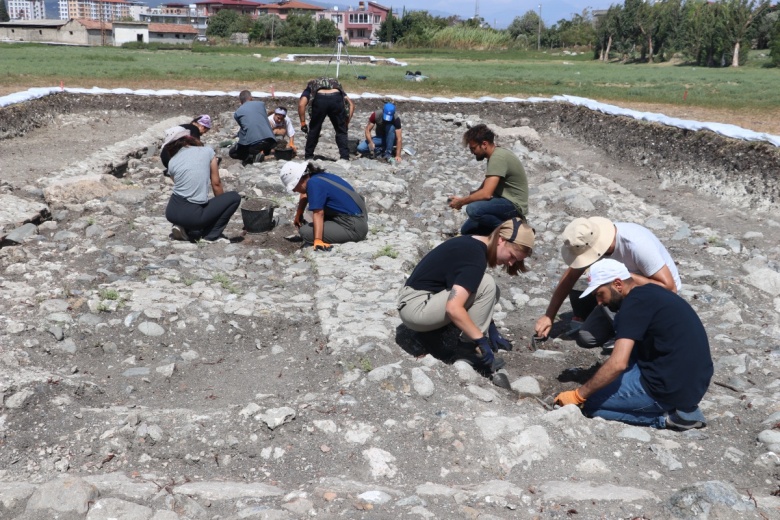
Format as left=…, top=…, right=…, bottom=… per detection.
left=615, top=284, right=713, bottom=410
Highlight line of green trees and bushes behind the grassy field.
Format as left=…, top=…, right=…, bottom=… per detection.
left=206, top=0, right=780, bottom=67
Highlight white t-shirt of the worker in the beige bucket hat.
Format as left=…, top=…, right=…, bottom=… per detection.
left=609, top=222, right=682, bottom=292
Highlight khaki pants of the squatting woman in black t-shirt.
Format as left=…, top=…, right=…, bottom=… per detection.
left=397, top=274, right=500, bottom=334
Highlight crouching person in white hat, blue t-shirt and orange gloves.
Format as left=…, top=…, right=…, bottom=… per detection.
left=281, top=161, right=368, bottom=251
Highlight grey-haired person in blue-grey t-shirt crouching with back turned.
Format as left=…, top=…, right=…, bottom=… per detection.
left=228, top=90, right=276, bottom=166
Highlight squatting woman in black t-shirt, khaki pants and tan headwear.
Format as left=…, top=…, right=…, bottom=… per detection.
left=398, top=218, right=534, bottom=372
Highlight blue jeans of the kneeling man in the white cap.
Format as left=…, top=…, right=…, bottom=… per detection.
left=582, top=363, right=674, bottom=429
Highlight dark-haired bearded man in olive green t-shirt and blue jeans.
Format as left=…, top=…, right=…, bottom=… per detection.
left=449, top=124, right=528, bottom=235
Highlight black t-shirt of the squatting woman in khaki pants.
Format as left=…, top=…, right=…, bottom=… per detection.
left=406, top=236, right=487, bottom=294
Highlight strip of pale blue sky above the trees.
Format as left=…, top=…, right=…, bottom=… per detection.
left=382, top=0, right=608, bottom=29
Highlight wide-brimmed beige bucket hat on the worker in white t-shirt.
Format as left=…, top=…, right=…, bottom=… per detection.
left=561, top=217, right=615, bottom=269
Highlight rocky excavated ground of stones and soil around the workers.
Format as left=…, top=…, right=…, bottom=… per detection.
left=0, top=96, right=780, bottom=520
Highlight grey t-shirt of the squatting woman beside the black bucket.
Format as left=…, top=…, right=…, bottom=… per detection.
left=168, top=146, right=214, bottom=204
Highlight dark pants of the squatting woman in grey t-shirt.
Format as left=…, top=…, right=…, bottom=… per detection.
left=165, top=191, right=241, bottom=240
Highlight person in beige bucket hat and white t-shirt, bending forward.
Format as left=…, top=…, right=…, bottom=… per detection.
left=534, top=217, right=682, bottom=348
